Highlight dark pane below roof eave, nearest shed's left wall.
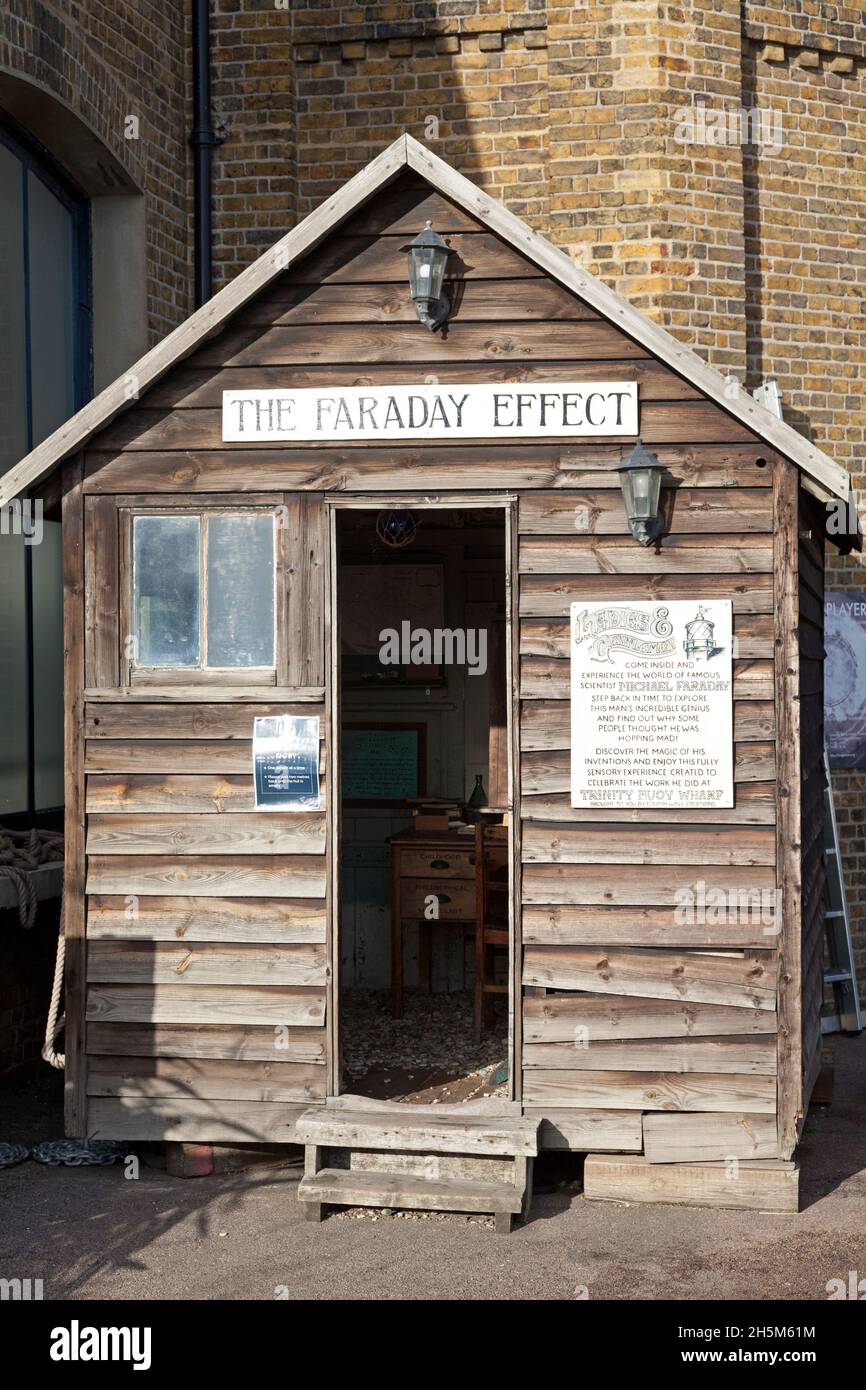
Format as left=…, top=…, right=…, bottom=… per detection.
left=31, top=521, right=63, bottom=810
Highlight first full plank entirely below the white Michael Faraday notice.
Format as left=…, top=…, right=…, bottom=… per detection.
left=523, top=812, right=776, bottom=866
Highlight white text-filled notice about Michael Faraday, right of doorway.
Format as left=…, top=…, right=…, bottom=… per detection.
left=571, top=599, right=734, bottom=809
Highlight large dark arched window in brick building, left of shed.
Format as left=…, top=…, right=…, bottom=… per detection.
left=0, top=124, right=92, bottom=820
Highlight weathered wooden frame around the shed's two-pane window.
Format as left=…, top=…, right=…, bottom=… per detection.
left=118, top=498, right=288, bottom=696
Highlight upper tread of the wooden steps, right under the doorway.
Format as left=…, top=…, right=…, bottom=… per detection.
left=296, top=1104, right=541, bottom=1158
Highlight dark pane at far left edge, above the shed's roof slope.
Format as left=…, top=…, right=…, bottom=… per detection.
left=0, top=145, right=28, bottom=473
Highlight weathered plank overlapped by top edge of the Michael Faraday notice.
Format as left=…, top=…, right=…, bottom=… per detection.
left=520, top=573, right=773, bottom=619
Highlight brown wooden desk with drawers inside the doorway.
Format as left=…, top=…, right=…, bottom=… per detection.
left=391, top=826, right=507, bottom=1017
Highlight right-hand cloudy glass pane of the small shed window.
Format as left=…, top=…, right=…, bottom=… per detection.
left=207, top=516, right=274, bottom=666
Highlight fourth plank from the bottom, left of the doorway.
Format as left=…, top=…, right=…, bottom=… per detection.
left=88, top=984, right=325, bottom=1027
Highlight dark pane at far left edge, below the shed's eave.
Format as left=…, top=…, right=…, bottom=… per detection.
left=0, top=535, right=28, bottom=816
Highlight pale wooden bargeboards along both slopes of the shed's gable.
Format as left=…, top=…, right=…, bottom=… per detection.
left=0, top=135, right=851, bottom=506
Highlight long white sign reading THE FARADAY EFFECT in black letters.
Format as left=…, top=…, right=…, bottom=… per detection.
left=222, top=381, right=638, bottom=443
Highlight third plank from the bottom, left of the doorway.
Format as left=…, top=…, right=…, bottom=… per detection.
left=88, top=1023, right=327, bottom=1069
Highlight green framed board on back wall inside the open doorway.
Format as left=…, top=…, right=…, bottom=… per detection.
left=341, top=724, right=427, bottom=806
